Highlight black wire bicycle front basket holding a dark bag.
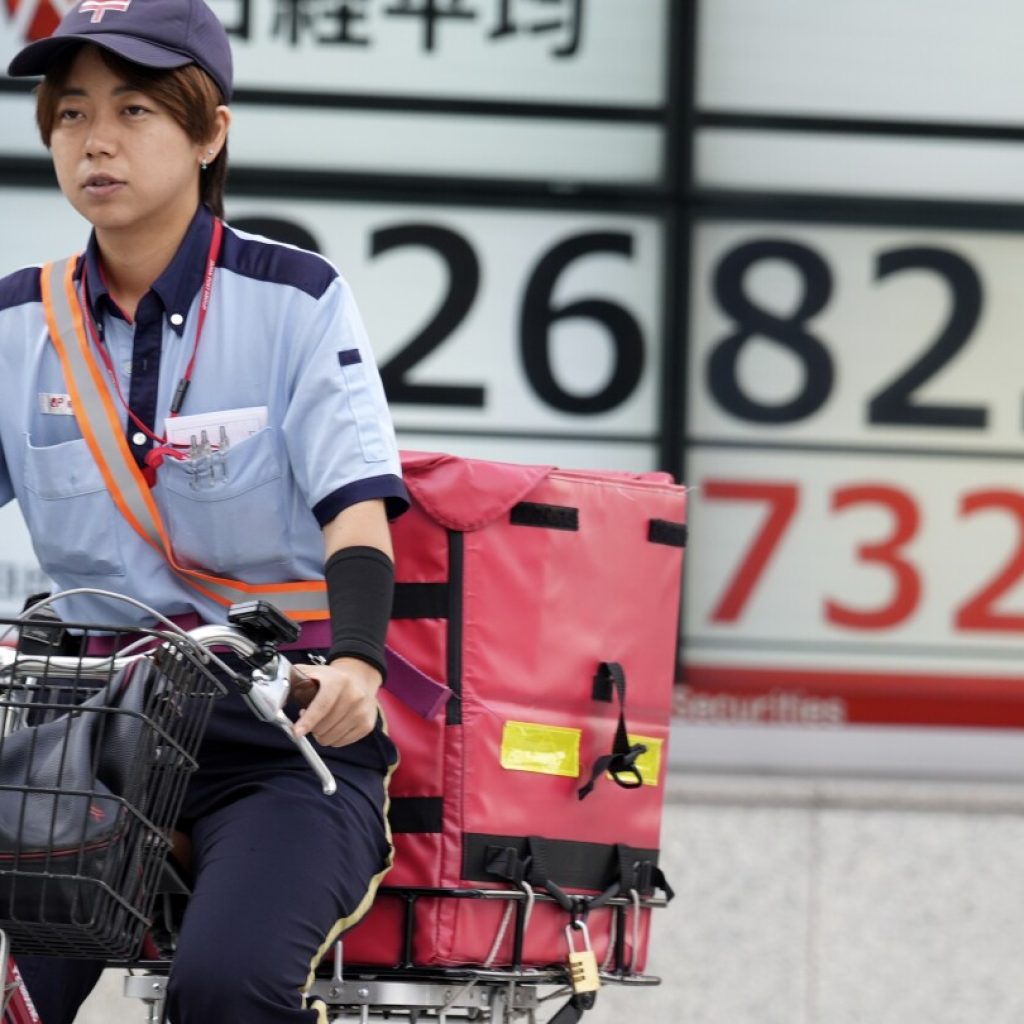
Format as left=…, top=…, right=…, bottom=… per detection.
left=0, top=621, right=223, bottom=961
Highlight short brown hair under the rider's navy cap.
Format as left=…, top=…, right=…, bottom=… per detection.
left=36, top=47, right=227, bottom=217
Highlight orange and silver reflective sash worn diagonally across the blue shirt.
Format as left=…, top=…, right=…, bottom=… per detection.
left=41, top=256, right=330, bottom=622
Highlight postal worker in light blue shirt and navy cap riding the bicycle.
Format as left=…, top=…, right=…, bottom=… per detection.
left=0, top=0, right=406, bottom=1024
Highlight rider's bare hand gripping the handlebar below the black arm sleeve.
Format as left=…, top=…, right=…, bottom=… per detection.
left=291, top=657, right=382, bottom=746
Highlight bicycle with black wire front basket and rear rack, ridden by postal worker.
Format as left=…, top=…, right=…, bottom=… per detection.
left=0, top=595, right=667, bottom=1024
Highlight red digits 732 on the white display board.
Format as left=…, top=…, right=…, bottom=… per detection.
left=702, top=480, right=1024, bottom=632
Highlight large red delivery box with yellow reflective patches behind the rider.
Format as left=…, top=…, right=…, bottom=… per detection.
left=344, top=453, right=686, bottom=972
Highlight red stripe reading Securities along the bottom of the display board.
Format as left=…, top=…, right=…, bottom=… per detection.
left=675, top=665, right=1024, bottom=729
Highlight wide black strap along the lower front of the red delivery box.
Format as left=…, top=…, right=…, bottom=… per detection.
left=462, top=833, right=658, bottom=892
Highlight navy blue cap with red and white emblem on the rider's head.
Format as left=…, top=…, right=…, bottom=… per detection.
left=7, top=0, right=231, bottom=101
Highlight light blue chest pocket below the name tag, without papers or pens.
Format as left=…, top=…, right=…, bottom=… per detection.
left=22, top=434, right=125, bottom=580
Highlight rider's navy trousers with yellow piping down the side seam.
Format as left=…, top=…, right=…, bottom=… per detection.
left=15, top=708, right=391, bottom=1024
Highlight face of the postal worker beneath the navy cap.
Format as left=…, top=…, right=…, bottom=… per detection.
left=50, top=46, right=216, bottom=233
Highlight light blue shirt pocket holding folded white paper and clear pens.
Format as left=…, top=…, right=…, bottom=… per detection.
left=159, top=427, right=291, bottom=574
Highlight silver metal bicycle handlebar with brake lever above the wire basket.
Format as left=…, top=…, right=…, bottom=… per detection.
left=0, top=626, right=337, bottom=797
